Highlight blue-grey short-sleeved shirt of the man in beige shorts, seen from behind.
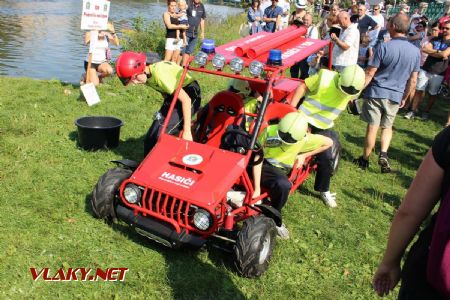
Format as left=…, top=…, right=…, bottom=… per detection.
left=364, top=38, right=420, bottom=103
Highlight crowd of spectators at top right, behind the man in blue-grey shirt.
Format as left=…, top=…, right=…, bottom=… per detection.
left=243, top=0, right=450, bottom=146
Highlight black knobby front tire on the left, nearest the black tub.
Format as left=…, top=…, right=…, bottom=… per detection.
left=91, top=168, right=132, bottom=219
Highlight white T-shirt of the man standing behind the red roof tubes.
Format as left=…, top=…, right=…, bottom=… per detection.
left=333, top=23, right=359, bottom=66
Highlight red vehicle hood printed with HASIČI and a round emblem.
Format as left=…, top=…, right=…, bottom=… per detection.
left=131, top=135, right=246, bottom=207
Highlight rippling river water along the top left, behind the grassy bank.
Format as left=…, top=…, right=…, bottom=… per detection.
left=0, top=0, right=242, bottom=83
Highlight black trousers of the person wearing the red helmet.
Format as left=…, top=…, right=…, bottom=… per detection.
left=144, top=81, right=201, bottom=156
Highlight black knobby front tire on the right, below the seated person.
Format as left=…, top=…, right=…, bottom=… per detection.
left=233, top=216, right=276, bottom=277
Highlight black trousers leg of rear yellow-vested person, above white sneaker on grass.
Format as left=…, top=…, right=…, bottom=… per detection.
left=311, top=126, right=339, bottom=192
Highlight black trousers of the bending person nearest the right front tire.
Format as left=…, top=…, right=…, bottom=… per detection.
left=261, top=161, right=292, bottom=213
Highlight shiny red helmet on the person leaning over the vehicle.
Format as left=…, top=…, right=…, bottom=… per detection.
left=116, top=51, right=146, bottom=85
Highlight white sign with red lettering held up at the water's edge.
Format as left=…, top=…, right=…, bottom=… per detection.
left=81, top=0, right=110, bottom=30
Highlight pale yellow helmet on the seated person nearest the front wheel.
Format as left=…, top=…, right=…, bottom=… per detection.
left=278, top=111, right=308, bottom=144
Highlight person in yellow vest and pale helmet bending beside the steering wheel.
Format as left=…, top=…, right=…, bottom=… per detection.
left=253, top=112, right=333, bottom=235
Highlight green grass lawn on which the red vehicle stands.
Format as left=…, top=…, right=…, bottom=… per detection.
left=0, top=71, right=448, bottom=299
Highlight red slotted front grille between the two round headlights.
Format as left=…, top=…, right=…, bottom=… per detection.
left=142, top=188, right=195, bottom=231
